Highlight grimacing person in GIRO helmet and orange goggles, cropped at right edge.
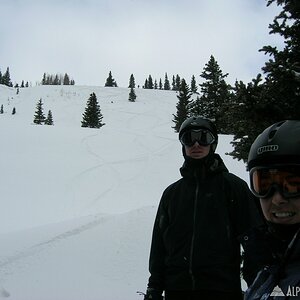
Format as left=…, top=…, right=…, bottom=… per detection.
left=243, top=120, right=300, bottom=300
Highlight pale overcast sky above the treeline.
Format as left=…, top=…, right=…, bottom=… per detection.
left=0, top=0, right=282, bottom=87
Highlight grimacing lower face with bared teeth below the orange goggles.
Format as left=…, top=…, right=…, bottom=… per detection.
left=260, top=191, right=300, bottom=224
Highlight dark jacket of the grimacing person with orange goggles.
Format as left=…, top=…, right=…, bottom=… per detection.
left=243, top=224, right=300, bottom=300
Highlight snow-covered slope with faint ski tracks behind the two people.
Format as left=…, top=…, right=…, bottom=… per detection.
left=0, top=85, right=247, bottom=300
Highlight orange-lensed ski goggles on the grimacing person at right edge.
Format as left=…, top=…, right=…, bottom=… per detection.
left=250, top=165, right=300, bottom=198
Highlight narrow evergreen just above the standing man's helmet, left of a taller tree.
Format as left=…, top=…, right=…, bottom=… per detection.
left=172, top=79, right=192, bottom=132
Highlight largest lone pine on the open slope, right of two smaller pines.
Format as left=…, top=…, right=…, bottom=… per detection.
left=81, top=93, right=105, bottom=128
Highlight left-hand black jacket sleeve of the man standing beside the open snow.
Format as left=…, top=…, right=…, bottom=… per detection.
left=148, top=193, right=168, bottom=291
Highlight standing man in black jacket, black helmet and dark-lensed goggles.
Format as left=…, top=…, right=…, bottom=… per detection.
left=144, top=116, right=260, bottom=300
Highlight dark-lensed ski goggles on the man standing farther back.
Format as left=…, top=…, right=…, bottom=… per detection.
left=180, top=129, right=216, bottom=147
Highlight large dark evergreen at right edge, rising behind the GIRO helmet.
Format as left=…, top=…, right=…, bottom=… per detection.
left=230, top=0, right=300, bottom=162
